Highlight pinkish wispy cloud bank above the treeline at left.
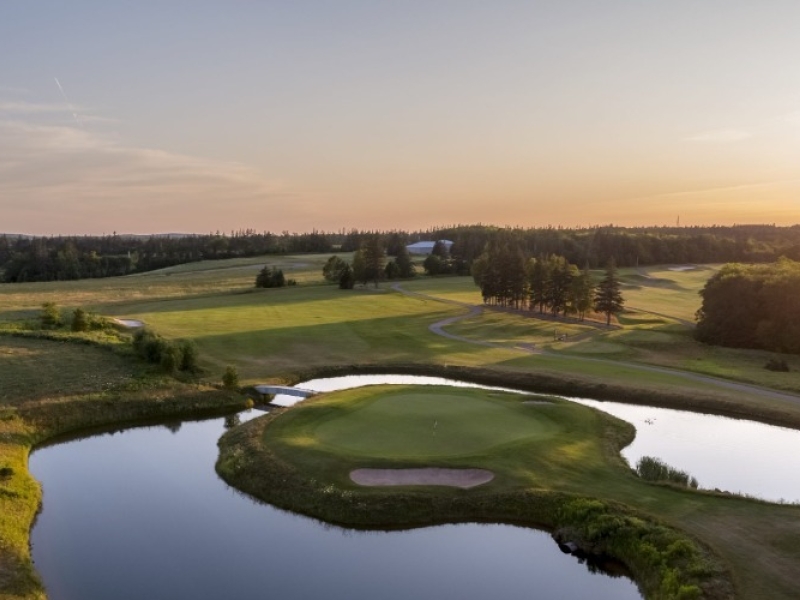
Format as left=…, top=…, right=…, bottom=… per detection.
left=0, top=102, right=312, bottom=232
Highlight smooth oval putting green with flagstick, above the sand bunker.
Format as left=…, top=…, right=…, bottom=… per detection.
left=303, top=388, right=561, bottom=459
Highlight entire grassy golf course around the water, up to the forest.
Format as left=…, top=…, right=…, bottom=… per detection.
left=0, top=255, right=800, bottom=600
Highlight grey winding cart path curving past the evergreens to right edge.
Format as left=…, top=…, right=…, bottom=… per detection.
left=392, top=283, right=800, bottom=405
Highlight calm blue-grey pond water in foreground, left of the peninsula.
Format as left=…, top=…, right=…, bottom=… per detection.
left=30, top=411, right=641, bottom=600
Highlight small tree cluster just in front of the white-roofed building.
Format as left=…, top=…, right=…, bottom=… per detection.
left=322, top=235, right=416, bottom=290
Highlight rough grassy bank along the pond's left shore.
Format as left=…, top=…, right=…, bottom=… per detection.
left=0, top=336, right=246, bottom=600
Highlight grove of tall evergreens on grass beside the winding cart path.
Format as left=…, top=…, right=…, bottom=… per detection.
left=472, top=236, right=624, bottom=324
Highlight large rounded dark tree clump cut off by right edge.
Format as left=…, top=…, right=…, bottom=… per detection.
left=695, top=258, right=800, bottom=354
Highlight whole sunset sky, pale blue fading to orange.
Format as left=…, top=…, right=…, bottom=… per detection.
left=0, top=0, right=800, bottom=235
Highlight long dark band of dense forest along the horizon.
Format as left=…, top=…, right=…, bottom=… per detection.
left=0, top=225, right=800, bottom=282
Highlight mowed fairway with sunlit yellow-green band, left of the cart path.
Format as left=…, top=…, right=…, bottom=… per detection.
left=131, top=286, right=515, bottom=383
